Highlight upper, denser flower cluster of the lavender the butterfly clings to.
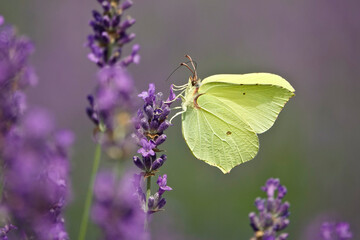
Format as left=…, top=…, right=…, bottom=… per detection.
left=133, top=84, right=175, bottom=176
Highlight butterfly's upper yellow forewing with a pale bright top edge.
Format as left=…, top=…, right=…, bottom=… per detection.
left=199, top=73, right=295, bottom=133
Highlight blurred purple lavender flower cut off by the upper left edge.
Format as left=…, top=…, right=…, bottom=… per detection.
left=0, top=16, right=37, bottom=144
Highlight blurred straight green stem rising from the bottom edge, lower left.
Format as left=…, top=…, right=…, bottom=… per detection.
left=78, top=144, right=101, bottom=240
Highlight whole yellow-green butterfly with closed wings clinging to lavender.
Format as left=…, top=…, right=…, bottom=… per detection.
left=172, top=55, right=295, bottom=173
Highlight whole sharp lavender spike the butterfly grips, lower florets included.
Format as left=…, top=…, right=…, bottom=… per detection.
left=133, top=84, right=175, bottom=217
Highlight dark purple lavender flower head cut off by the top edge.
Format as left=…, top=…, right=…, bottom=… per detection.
left=87, top=0, right=140, bottom=67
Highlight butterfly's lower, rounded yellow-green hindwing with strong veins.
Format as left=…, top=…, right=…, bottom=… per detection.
left=182, top=94, right=259, bottom=173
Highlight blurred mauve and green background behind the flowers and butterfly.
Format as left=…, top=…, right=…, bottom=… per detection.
left=0, top=0, right=360, bottom=240
